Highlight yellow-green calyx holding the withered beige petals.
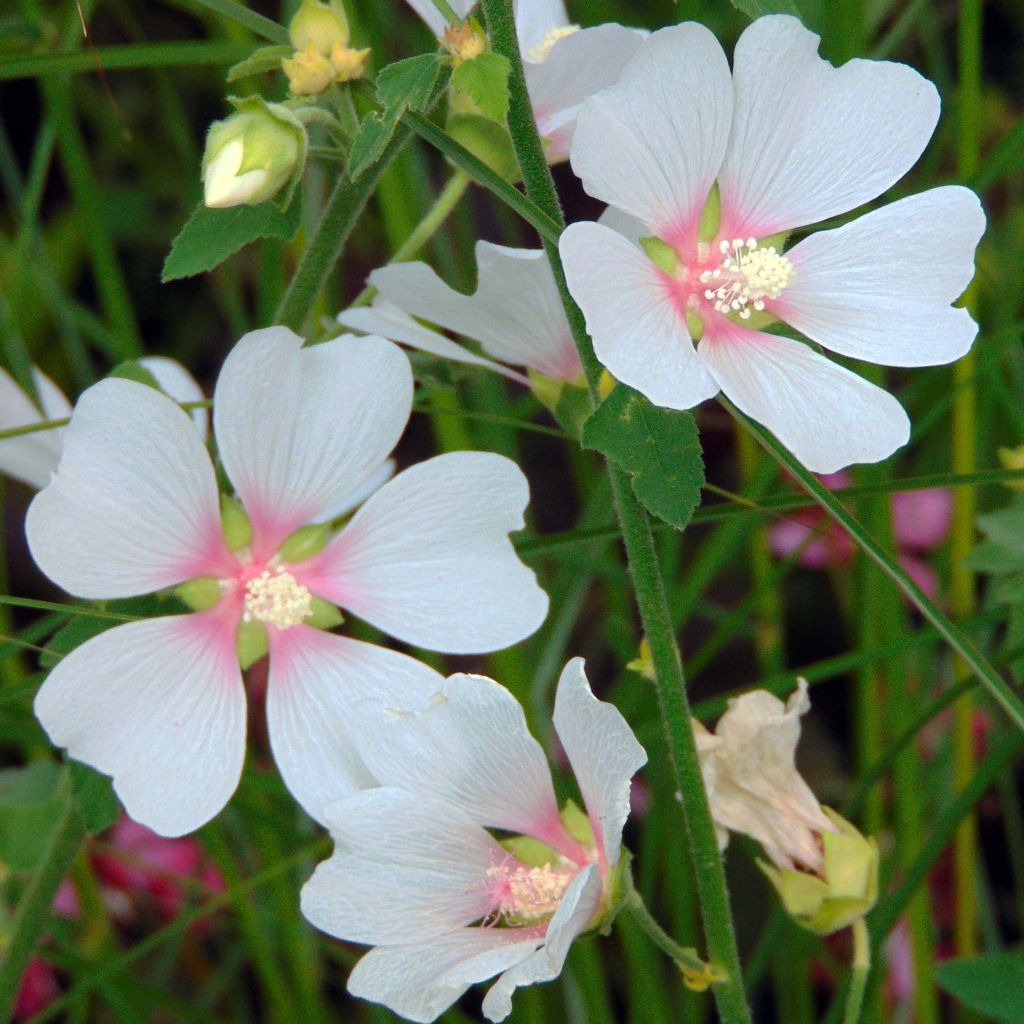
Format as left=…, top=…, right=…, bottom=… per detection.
left=758, top=807, right=879, bottom=935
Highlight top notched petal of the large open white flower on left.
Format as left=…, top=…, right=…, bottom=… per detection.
left=213, top=327, right=413, bottom=558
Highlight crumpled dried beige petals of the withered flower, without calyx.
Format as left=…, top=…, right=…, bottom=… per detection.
left=693, top=679, right=837, bottom=871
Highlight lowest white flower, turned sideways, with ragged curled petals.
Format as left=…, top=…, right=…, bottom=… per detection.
left=302, top=658, right=646, bottom=1021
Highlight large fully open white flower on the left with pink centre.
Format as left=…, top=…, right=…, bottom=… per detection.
left=27, top=328, right=547, bottom=836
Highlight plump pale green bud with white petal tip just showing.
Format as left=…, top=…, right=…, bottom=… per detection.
left=203, top=98, right=306, bottom=209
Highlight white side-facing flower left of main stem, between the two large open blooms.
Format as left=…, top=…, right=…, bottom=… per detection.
left=338, top=242, right=583, bottom=384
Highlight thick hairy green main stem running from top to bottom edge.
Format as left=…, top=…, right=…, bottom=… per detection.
left=481, top=0, right=751, bottom=1024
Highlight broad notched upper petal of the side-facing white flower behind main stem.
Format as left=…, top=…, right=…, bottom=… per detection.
left=370, top=242, right=581, bottom=380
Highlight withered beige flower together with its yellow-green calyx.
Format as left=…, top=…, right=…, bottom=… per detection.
left=693, top=679, right=879, bottom=935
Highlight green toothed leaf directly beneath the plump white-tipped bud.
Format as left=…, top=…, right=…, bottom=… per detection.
left=161, top=199, right=302, bottom=283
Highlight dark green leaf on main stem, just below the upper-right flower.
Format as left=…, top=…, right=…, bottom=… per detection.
left=583, top=384, right=705, bottom=529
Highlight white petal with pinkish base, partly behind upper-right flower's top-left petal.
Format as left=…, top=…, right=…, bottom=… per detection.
left=532, top=25, right=645, bottom=163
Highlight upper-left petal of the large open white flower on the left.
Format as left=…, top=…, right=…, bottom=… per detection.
left=26, top=380, right=228, bottom=598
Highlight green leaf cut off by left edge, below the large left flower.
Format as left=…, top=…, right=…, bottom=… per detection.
left=0, top=761, right=67, bottom=871
